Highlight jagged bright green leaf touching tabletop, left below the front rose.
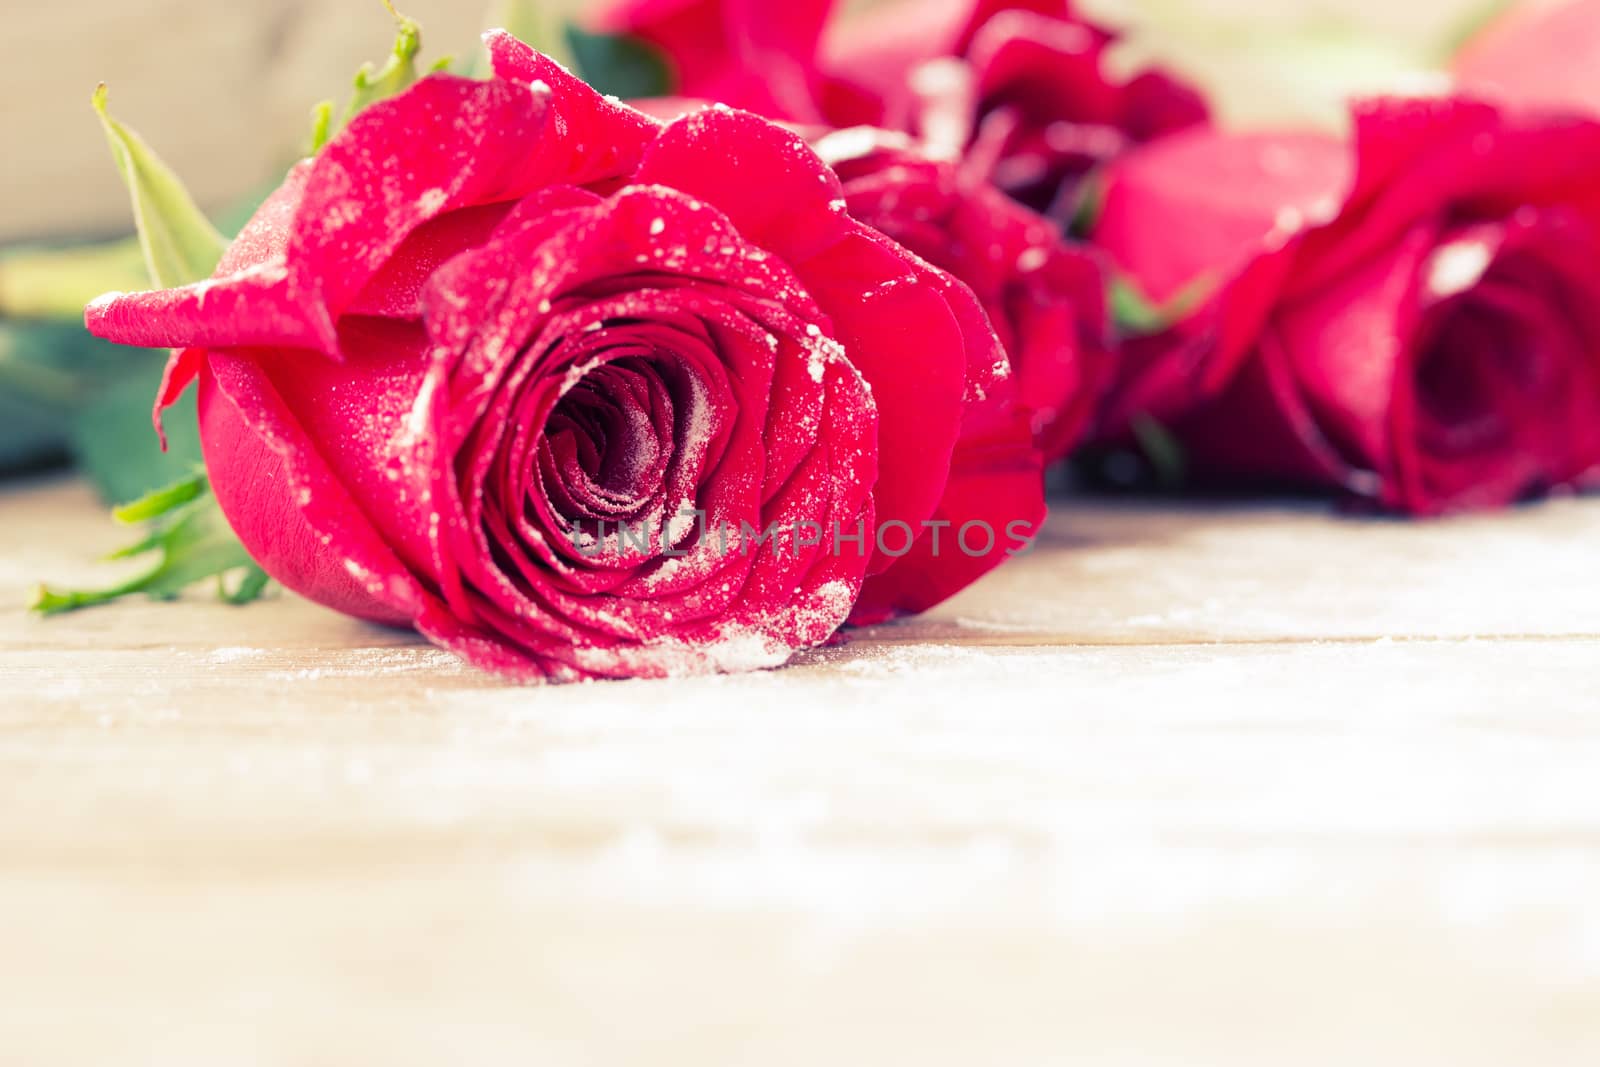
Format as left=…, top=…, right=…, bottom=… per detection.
left=29, top=470, right=267, bottom=614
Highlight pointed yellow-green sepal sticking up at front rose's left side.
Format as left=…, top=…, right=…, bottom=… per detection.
left=93, top=83, right=227, bottom=288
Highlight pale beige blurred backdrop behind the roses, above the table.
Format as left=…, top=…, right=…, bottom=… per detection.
left=0, top=0, right=1494, bottom=240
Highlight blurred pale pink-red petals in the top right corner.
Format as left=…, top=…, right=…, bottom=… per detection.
left=1454, top=0, right=1600, bottom=115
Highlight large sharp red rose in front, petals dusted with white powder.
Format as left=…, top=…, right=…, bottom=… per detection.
left=88, top=34, right=1043, bottom=678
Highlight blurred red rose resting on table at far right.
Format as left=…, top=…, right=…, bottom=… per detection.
left=1094, top=101, right=1600, bottom=514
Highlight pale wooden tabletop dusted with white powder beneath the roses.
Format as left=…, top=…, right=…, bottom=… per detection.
left=0, top=480, right=1600, bottom=1067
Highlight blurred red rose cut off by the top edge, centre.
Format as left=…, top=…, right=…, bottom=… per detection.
left=600, top=0, right=1206, bottom=224
